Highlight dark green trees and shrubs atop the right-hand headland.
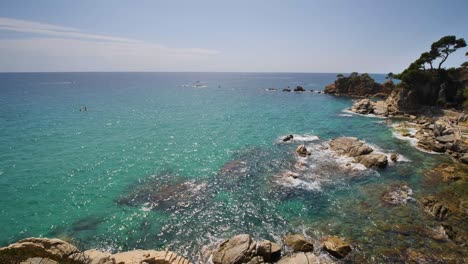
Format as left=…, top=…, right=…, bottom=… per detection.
left=394, top=36, right=468, bottom=107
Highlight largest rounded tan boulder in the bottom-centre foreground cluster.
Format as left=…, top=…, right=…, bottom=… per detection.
left=212, top=234, right=256, bottom=264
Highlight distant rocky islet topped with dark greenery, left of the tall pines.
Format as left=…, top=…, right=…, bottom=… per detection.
left=324, top=73, right=392, bottom=96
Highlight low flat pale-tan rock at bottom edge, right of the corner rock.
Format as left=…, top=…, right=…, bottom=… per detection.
left=112, top=250, right=190, bottom=264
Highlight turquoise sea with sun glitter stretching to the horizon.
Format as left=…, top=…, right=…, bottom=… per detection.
left=0, top=73, right=446, bottom=260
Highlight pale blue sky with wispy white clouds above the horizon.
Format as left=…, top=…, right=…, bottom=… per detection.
left=0, top=0, right=468, bottom=73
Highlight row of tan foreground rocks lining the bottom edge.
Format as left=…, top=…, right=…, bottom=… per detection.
left=0, top=234, right=352, bottom=264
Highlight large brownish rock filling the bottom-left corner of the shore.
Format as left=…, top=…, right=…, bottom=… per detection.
left=0, top=238, right=79, bottom=263
